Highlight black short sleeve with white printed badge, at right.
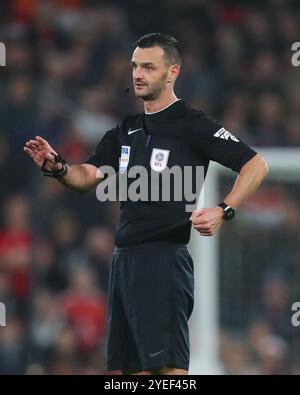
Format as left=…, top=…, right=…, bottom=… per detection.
left=191, top=112, right=257, bottom=172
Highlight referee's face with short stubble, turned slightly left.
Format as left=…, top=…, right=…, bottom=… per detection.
left=131, top=46, right=174, bottom=101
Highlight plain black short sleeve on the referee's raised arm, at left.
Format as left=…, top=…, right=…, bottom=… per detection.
left=85, top=128, right=120, bottom=172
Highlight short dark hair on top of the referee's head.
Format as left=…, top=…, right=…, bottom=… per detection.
left=133, top=33, right=181, bottom=65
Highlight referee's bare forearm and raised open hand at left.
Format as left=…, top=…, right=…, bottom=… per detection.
left=24, top=136, right=103, bottom=191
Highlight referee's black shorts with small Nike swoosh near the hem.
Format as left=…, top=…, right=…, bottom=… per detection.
left=107, top=242, right=194, bottom=371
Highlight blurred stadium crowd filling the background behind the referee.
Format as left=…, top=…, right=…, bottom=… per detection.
left=0, top=0, right=300, bottom=374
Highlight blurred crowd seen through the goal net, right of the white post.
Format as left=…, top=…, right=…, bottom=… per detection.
left=219, top=180, right=300, bottom=375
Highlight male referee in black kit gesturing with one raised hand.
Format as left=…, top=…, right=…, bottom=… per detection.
left=24, top=33, right=268, bottom=375
